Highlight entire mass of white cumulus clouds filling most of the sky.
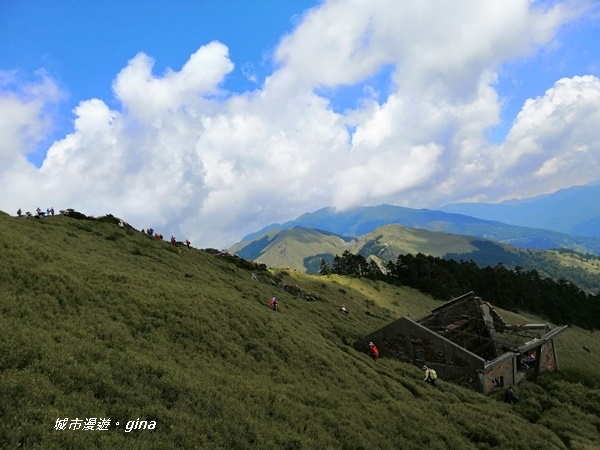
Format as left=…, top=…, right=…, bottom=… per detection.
left=0, top=0, right=600, bottom=247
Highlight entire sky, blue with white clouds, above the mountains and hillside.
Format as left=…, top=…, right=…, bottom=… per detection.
left=0, top=0, right=600, bottom=245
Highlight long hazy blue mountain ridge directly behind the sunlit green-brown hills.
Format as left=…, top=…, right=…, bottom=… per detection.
left=242, top=205, right=600, bottom=255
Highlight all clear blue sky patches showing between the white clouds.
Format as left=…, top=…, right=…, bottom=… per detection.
left=0, top=0, right=600, bottom=153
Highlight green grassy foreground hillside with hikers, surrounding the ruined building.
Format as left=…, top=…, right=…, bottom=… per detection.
left=0, top=213, right=600, bottom=450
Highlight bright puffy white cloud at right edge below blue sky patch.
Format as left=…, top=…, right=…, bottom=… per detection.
left=494, top=75, right=600, bottom=197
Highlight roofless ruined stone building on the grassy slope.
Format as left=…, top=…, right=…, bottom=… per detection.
left=354, top=292, right=567, bottom=394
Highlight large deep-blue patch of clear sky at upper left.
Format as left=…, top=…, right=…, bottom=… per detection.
left=0, top=0, right=318, bottom=165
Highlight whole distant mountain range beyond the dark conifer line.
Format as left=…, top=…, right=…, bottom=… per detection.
left=229, top=193, right=600, bottom=292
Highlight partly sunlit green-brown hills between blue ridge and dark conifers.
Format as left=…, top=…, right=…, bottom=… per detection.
left=231, top=224, right=600, bottom=294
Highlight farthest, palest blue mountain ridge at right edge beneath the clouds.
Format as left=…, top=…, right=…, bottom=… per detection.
left=440, top=184, right=600, bottom=236
